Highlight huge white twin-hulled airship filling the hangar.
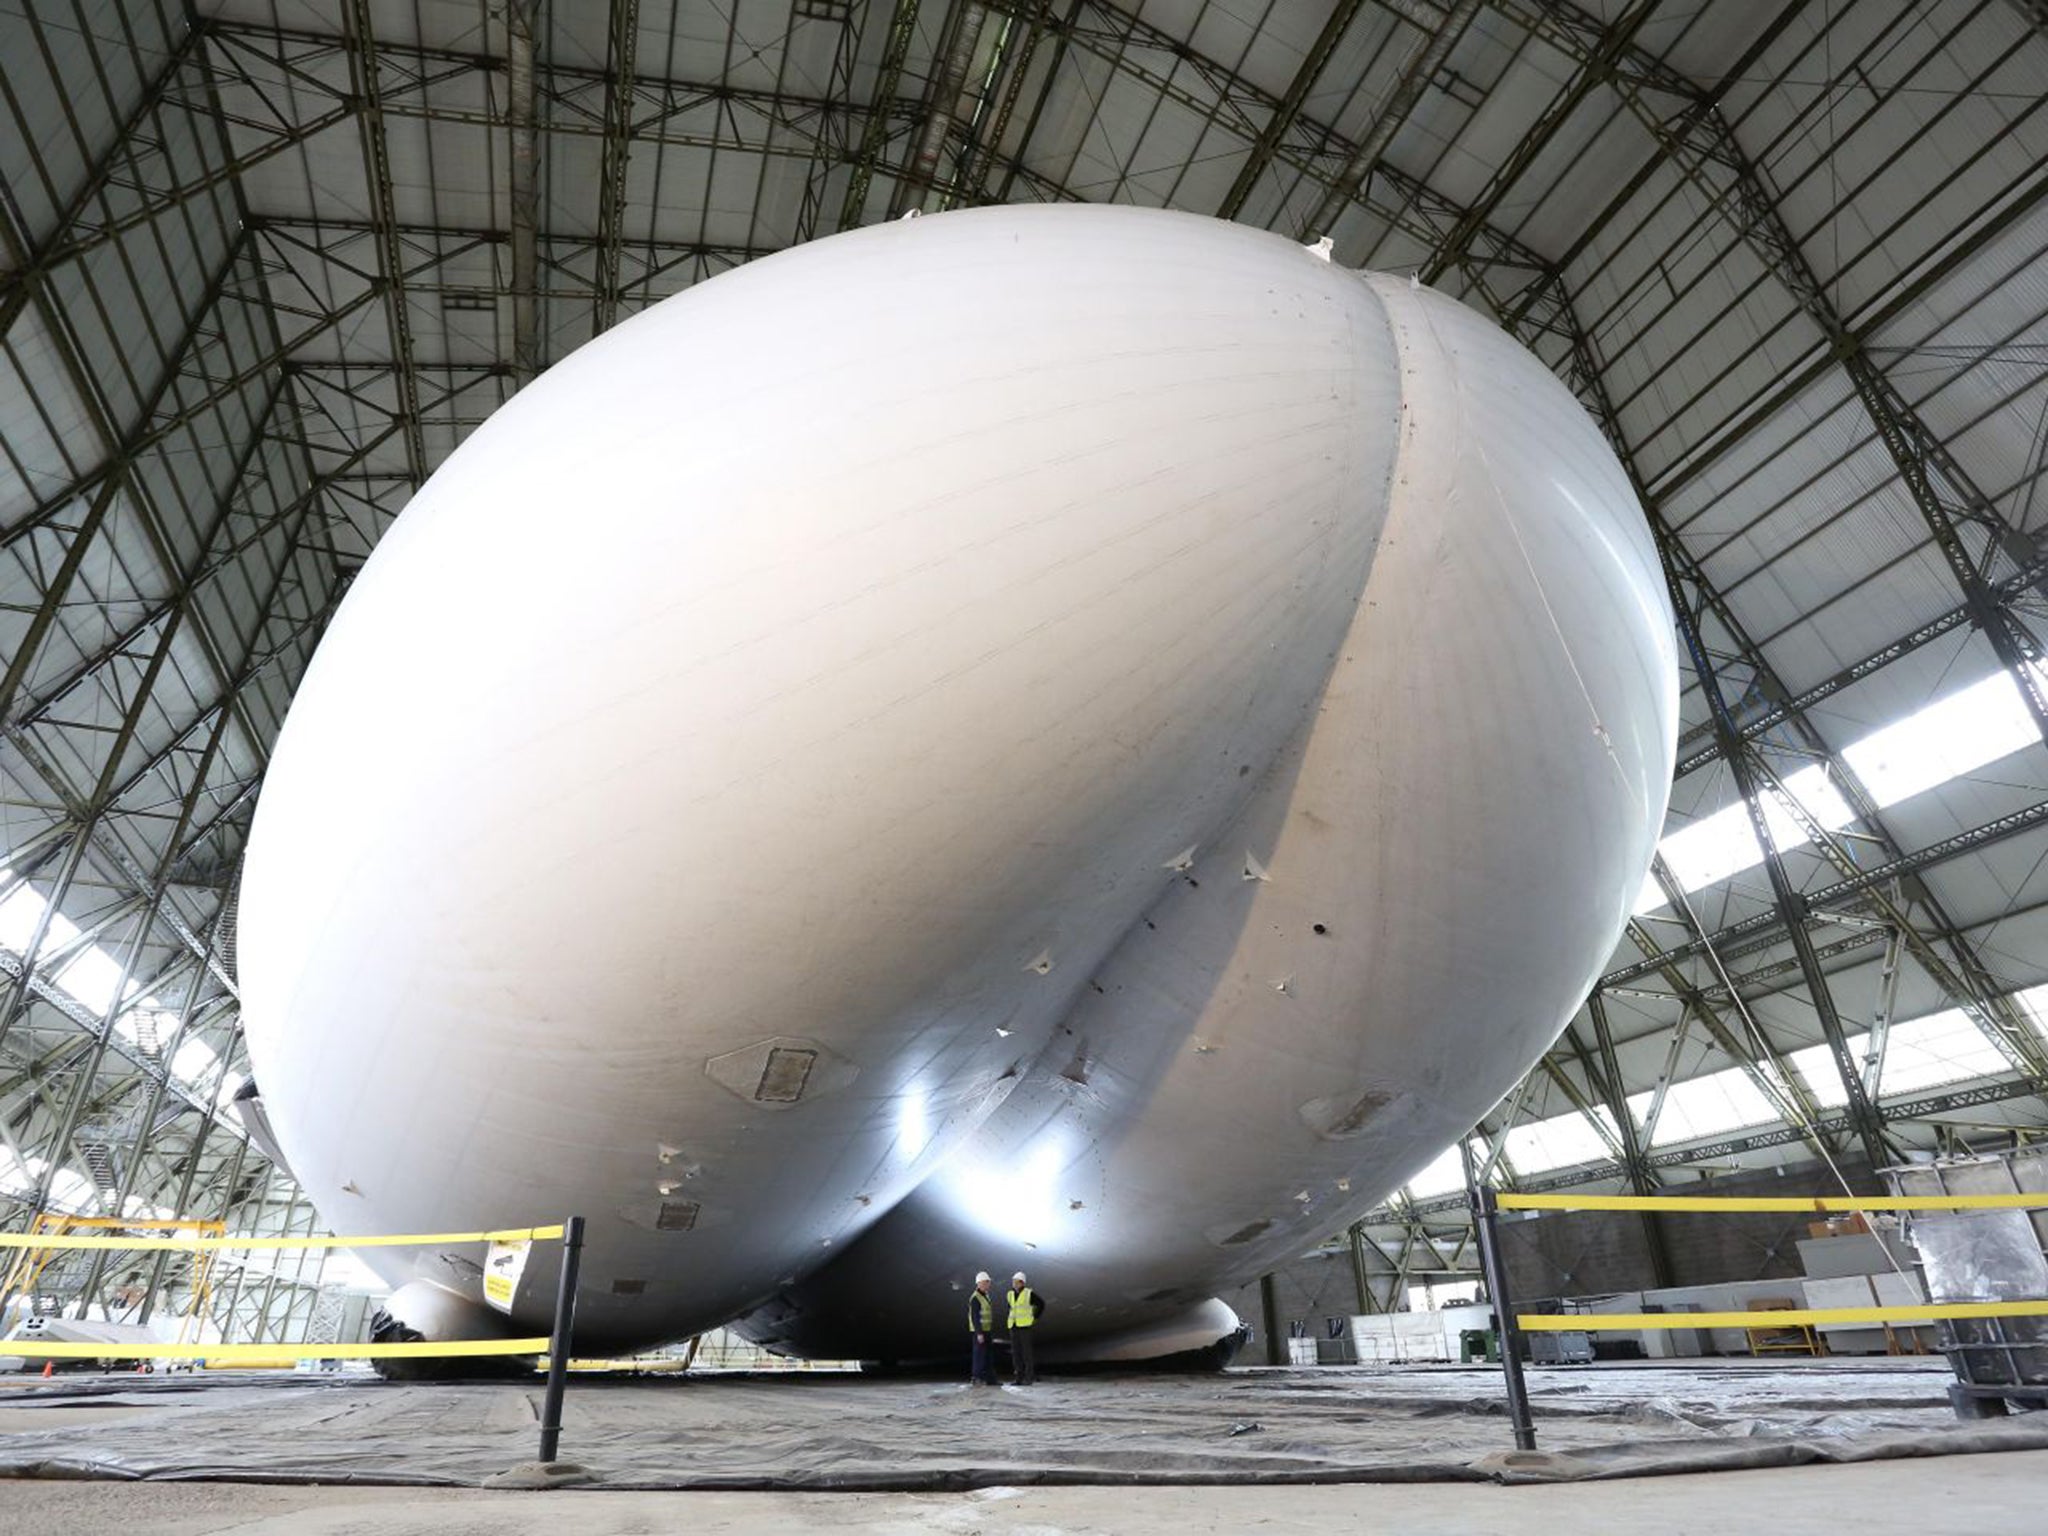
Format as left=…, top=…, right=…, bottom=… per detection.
left=238, top=205, right=1677, bottom=1362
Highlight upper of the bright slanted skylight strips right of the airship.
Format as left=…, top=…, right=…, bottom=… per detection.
left=1634, top=670, right=2048, bottom=915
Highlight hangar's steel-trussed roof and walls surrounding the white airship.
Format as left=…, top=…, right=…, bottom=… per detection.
left=0, top=0, right=2048, bottom=1368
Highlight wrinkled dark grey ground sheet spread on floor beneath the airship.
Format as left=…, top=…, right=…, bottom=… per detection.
left=0, top=1360, right=2048, bottom=1491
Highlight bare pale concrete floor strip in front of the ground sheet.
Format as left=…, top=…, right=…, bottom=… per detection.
left=0, top=1450, right=2048, bottom=1536
